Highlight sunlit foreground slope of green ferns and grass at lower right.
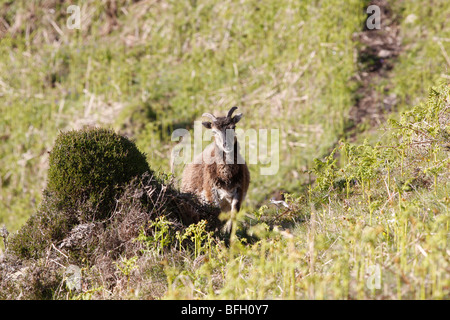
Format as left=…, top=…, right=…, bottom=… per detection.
left=108, top=85, right=450, bottom=299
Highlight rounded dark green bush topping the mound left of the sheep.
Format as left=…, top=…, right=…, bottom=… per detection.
left=47, top=128, right=150, bottom=221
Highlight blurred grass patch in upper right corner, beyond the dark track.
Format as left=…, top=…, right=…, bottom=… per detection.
left=391, top=0, right=450, bottom=109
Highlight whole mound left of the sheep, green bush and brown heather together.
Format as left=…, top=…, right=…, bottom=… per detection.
left=0, top=129, right=222, bottom=299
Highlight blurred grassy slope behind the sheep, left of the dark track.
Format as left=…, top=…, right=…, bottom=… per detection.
left=0, top=1, right=363, bottom=229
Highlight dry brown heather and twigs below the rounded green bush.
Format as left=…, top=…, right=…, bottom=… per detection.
left=0, top=172, right=222, bottom=299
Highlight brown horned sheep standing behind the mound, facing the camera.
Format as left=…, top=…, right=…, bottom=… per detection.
left=181, top=107, right=250, bottom=232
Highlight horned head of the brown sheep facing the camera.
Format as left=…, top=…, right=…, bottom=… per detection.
left=202, top=107, right=242, bottom=153
